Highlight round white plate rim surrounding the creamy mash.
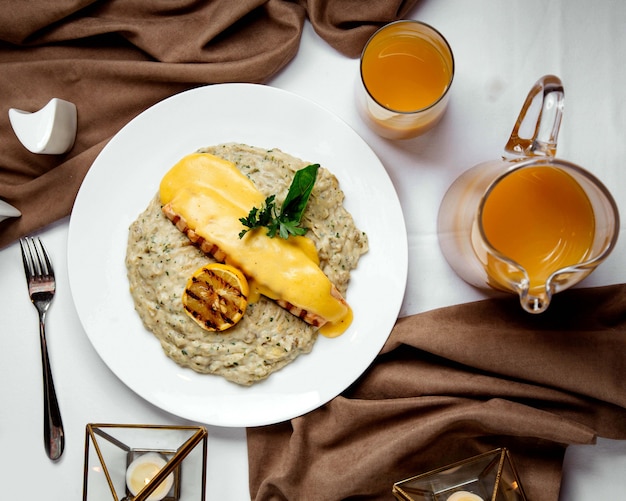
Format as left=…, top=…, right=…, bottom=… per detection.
left=68, top=84, right=408, bottom=427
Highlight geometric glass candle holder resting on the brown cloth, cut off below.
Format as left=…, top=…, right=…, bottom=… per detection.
left=392, top=448, right=526, bottom=501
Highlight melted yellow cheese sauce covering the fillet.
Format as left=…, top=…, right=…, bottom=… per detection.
left=160, top=153, right=352, bottom=337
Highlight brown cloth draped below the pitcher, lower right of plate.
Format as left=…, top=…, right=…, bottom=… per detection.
left=248, top=284, right=626, bottom=501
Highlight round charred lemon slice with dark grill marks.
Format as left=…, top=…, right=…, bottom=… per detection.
left=183, top=263, right=249, bottom=331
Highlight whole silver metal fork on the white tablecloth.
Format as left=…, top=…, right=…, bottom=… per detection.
left=20, top=237, right=65, bottom=460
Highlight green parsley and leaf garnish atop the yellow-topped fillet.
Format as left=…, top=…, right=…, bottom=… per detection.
left=239, top=164, right=320, bottom=239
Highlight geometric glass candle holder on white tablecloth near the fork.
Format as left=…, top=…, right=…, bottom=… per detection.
left=83, top=424, right=207, bottom=501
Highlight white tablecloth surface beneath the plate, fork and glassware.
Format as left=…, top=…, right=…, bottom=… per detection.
left=0, top=0, right=626, bottom=501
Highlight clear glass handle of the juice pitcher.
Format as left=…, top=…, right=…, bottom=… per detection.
left=504, top=75, right=564, bottom=157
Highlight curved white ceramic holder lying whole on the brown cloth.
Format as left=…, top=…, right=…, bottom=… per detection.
left=9, top=97, right=77, bottom=155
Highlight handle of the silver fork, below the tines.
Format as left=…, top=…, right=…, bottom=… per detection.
left=39, top=319, right=65, bottom=460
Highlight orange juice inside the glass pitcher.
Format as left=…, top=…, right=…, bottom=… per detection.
left=482, top=165, right=595, bottom=290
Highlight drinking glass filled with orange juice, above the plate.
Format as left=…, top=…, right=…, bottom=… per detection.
left=357, top=20, right=454, bottom=139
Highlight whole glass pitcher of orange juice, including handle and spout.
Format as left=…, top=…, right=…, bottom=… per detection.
left=437, top=75, right=619, bottom=313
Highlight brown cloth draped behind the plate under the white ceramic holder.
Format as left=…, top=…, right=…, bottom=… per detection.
left=0, top=0, right=417, bottom=248
